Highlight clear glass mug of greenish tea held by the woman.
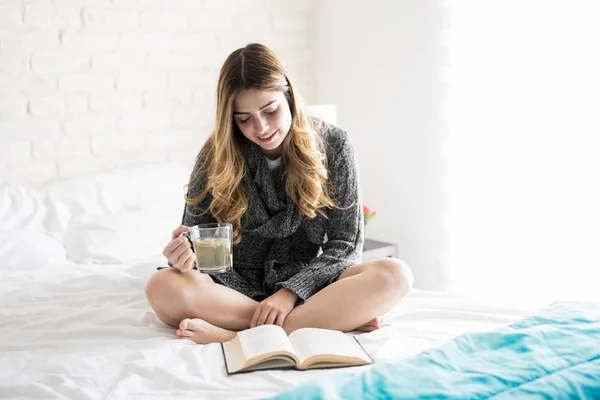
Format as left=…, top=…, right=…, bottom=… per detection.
left=183, top=223, right=233, bottom=274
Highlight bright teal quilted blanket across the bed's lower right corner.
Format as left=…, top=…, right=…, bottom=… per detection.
left=276, top=302, right=600, bottom=400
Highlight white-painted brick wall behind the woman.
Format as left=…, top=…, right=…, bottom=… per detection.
left=0, top=0, right=314, bottom=184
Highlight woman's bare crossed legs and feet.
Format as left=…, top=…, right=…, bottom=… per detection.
left=146, top=258, right=412, bottom=343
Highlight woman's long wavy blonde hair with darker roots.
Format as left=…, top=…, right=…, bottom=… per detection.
left=186, top=43, right=335, bottom=243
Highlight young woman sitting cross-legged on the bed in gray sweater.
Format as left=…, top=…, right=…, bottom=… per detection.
left=146, top=44, right=412, bottom=343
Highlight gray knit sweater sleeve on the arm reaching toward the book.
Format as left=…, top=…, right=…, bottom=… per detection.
left=275, top=134, right=364, bottom=300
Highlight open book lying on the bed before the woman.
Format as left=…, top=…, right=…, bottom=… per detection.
left=222, top=325, right=373, bottom=374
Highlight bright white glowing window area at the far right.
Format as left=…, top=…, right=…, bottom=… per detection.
left=444, top=0, right=600, bottom=306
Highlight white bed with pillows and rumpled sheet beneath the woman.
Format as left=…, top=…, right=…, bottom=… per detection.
left=0, top=165, right=524, bottom=400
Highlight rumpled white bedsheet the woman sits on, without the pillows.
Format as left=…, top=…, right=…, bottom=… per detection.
left=0, top=259, right=522, bottom=400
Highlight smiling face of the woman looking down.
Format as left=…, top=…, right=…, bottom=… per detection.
left=233, top=89, right=292, bottom=159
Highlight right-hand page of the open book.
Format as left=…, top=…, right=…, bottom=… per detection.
left=290, top=328, right=371, bottom=363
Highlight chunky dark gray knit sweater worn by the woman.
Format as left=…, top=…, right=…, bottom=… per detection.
left=182, top=123, right=363, bottom=302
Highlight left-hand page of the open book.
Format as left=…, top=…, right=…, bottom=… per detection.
left=237, top=325, right=295, bottom=360
